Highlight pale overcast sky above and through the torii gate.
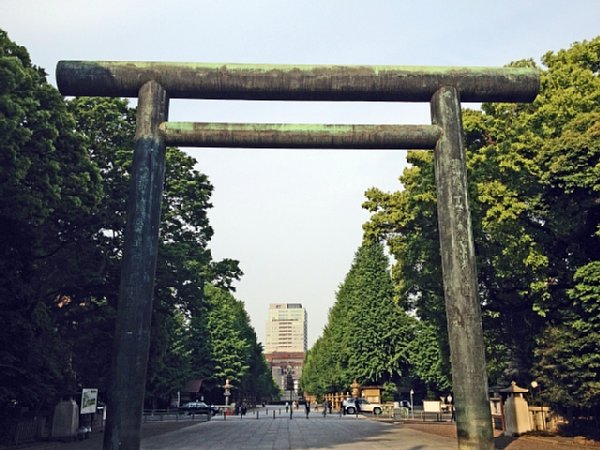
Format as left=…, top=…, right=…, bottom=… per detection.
left=0, top=0, right=600, bottom=345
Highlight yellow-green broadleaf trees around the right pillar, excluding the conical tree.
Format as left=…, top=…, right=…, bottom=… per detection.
left=365, top=38, right=600, bottom=420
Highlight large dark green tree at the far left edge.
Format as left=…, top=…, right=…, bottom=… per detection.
left=0, top=30, right=102, bottom=408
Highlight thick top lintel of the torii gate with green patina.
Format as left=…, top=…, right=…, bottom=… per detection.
left=56, top=61, right=540, bottom=102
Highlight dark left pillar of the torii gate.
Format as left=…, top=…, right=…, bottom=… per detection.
left=104, top=81, right=168, bottom=450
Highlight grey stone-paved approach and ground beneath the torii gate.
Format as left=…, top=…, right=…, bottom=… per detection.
left=5, top=411, right=597, bottom=450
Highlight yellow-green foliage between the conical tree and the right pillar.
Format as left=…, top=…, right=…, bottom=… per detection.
left=363, top=151, right=450, bottom=389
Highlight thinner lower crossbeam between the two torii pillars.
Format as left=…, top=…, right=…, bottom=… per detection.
left=160, top=122, right=441, bottom=149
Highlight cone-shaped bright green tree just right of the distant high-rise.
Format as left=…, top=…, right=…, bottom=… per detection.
left=301, top=243, right=417, bottom=394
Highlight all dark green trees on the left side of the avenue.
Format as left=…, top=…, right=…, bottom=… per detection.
left=0, top=31, right=272, bottom=418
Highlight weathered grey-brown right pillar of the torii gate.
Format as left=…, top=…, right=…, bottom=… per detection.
left=431, top=87, right=494, bottom=450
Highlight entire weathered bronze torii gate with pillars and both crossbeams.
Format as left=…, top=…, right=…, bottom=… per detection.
left=56, top=61, right=540, bottom=450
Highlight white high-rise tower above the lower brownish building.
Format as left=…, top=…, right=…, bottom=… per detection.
left=264, top=303, right=308, bottom=353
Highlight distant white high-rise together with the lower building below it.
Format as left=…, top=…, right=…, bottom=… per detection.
left=265, top=303, right=308, bottom=400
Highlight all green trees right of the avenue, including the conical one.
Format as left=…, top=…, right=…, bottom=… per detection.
left=302, top=37, right=600, bottom=429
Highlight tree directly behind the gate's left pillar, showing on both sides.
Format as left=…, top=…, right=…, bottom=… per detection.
left=69, top=94, right=246, bottom=406
